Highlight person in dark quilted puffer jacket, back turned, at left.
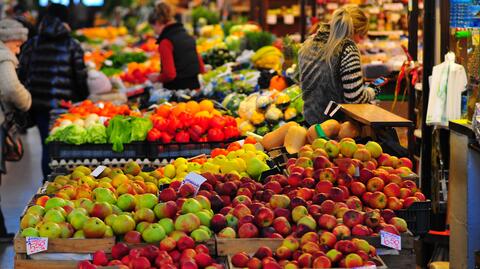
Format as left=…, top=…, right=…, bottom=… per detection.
left=19, top=4, right=88, bottom=178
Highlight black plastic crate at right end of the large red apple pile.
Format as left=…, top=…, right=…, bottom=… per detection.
left=395, top=201, right=432, bottom=235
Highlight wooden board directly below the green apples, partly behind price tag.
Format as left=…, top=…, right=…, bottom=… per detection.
left=13, top=233, right=115, bottom=254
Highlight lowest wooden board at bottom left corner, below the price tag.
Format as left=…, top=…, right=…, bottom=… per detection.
left=14, top=254, right=119, bottom=269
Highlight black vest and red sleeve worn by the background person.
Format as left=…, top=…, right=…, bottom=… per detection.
left=158, top=23, right=201, bottom=90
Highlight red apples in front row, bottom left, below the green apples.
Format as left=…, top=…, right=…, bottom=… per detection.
left=78, top=236, right=224, bottom=269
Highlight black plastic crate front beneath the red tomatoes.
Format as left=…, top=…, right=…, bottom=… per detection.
left=147, top=138, right=242, bottom=160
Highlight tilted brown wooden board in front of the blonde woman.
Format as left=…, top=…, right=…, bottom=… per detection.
left=342, top=104, right=413, bottom=127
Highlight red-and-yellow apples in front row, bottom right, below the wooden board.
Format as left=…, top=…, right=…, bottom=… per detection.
left=231, top=232, right=381, bottom=269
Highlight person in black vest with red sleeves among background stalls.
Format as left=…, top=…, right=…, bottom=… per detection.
left=149, top=2, right=204, bottom=90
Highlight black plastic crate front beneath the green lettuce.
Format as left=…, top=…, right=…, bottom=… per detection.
left=48, top=142, right=147, bottom=160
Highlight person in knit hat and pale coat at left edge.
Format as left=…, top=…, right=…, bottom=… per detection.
left=0, top=19, right=32, bottom=241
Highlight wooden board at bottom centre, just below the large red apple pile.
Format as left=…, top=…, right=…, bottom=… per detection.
left=216, top=237, right=283, bottom=256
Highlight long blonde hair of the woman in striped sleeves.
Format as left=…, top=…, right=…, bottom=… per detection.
left=322, top=5, right=368, bottom=68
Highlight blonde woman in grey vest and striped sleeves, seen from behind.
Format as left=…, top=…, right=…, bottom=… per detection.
left=299, top=5, right=377, bottom=125
